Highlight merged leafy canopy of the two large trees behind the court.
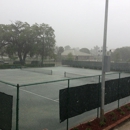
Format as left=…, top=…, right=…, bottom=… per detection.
left=0, top=21, right=55, bottom=64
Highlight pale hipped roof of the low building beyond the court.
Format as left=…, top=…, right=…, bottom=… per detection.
left=61, top=49, right=91, bottom=56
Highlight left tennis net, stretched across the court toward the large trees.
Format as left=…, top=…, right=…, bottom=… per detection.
left=21, top=68, right=52, bottom=75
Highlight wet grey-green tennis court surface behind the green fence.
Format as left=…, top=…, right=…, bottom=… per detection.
left=0, top=67, right=129, bottom=130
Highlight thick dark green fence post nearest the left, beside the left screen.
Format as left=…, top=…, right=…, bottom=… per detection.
left=16, top=84, right=19, bottom=130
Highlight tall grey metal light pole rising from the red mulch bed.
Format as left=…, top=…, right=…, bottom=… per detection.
left=100, top=0, right=108, bottom=121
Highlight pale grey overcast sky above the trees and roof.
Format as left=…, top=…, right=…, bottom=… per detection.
left=0, top=0, right=130, bottom=49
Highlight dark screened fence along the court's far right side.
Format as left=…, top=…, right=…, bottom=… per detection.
left=62, top=60, right=130, bottom=72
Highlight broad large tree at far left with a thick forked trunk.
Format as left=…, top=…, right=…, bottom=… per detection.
left=0, top=21, right=33, bottom=64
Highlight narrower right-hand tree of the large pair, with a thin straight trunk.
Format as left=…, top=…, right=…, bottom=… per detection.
left=32, top=23, right=55, bottom=64
